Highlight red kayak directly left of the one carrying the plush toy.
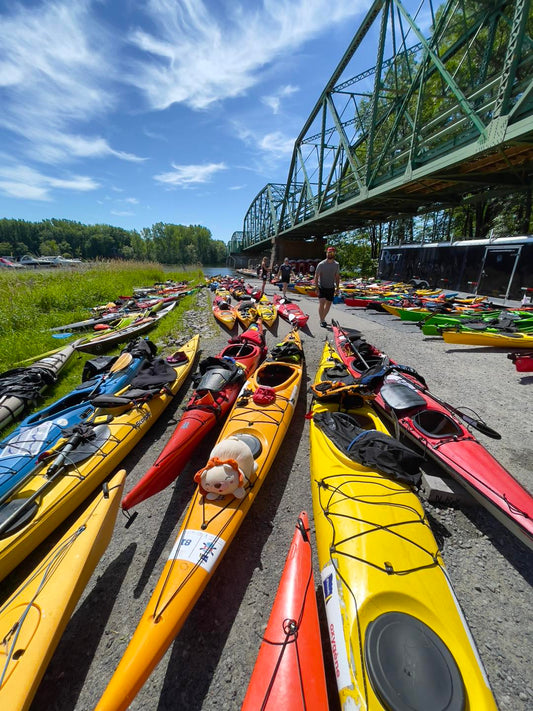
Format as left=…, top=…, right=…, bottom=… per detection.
left=122, top=321, right=267, bottom=511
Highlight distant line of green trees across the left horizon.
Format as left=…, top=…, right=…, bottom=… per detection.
left=0, top=218, right=226, bottom=264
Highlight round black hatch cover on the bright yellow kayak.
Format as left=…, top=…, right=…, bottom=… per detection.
left=365, top=612, right=466, bottom=711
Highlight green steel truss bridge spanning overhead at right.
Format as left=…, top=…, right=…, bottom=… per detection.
left=242, top=0, right=533, bottom=251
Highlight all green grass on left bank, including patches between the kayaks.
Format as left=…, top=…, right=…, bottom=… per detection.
left=0, top=261, right=204, bottom=428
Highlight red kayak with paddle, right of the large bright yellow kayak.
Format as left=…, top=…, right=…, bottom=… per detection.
left=332, top=322, right=533, bottom=548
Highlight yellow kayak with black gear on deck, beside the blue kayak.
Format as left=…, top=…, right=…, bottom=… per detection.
left=0, top=335, right=199, bottom=580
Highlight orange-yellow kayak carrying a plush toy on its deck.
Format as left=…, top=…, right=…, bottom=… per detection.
left=96, top=331, right=303, bottom=711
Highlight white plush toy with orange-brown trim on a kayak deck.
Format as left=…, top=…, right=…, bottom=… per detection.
left=194, top=437, right=257, bottom=500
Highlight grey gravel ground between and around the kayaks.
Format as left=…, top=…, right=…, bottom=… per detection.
left=31, top=285, right=533, bottom=711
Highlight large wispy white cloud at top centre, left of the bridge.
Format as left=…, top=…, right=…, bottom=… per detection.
left=128, top=0, right=367, bottom=109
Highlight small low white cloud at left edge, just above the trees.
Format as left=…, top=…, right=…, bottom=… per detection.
left=0, top=165, right=99, bottom=201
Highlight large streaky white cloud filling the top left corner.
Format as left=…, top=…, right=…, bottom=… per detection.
left=0, top=0, right=139, bottom=164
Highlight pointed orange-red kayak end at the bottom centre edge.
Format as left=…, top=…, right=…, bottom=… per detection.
left=241, top=511, right=328, bottom=711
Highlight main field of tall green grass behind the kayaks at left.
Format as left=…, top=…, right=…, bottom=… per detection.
left=0, top=261, right=203, bottom=372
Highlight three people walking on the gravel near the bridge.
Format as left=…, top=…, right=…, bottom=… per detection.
left=258, top=247, right=340, bottom=328
